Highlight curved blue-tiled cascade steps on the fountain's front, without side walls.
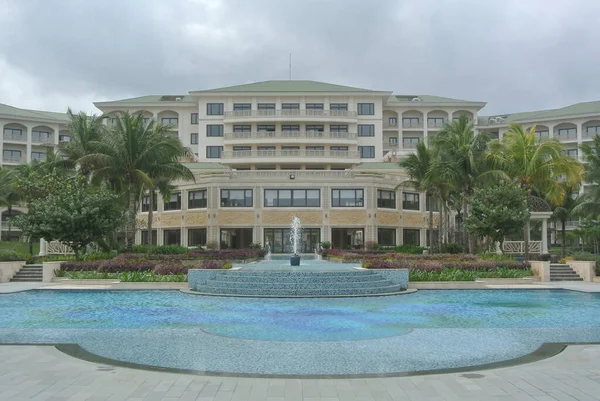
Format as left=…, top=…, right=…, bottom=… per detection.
left=198, top=270, right=404, bottom=297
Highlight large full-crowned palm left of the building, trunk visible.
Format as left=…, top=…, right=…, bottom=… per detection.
left=77, top=113, right=192, bottom=250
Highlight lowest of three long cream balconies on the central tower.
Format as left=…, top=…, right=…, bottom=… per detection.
left=221, top=150, right=360, bottom=163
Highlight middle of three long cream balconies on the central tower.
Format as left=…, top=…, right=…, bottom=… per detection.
left=223, top=131, right=357, bottom=143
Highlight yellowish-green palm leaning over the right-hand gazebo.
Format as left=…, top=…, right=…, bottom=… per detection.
left=487, top=123, right=583, bottom=260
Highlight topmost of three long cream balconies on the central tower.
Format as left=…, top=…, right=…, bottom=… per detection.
left=224, top=109, right=357, bottom=122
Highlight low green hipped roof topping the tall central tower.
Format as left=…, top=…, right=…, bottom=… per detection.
left=197, top=80, right=377, bottom=92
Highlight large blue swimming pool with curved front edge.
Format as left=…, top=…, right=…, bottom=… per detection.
left=0, top=290, right=600, bottom=374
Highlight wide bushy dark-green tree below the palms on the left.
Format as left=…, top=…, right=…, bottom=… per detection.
left=14, top=174, right=123, bottom=259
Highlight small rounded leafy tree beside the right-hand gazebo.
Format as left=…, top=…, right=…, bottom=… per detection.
left=465, top=184, right=530, bottom=249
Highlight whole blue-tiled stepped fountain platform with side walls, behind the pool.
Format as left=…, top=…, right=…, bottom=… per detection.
left=188, top=257, right=408, bottom=298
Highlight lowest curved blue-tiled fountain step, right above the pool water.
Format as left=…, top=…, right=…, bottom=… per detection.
left=197, top=285, right=402, bottom=297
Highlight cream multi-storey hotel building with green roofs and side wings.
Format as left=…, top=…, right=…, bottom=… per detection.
left=0, top=81, right=600, bottom=252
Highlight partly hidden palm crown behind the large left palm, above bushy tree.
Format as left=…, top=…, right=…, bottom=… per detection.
left=58, top=109, right=105, bottom=177
